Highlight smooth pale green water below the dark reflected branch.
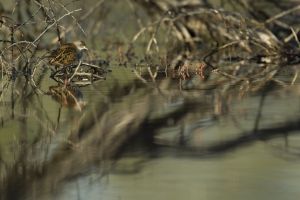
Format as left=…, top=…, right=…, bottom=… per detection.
left=59, top=142, right=299, bottom=200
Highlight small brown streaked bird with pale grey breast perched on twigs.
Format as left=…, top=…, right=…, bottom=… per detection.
left=42, top=40, right=88, bottom=66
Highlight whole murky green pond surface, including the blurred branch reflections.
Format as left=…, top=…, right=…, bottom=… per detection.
left=0, top=1, right=300, bottom=200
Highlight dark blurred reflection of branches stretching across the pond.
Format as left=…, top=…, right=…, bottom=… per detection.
left=1, top=57, right=299, bottom=199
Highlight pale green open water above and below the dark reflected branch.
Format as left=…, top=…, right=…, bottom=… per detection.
left=79, top=76, right=300, bottom=200
